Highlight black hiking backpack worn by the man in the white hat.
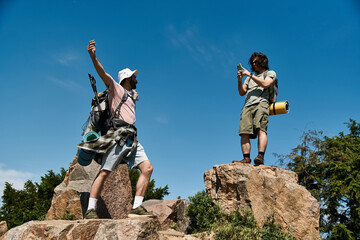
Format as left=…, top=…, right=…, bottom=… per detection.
left=82, top=73, right=129, bottom=136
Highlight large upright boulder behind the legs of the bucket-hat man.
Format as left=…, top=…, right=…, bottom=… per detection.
left=46, top=151, right=132, bottom=220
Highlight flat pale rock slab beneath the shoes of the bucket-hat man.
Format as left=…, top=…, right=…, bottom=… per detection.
left=0, top=215, right=160, bottom=240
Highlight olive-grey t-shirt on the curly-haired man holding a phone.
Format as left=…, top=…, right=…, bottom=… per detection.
left=244, top=70, right=276, bottom=107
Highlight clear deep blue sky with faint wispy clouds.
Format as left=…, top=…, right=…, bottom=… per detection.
left=0, top=0, right=360, bottom=199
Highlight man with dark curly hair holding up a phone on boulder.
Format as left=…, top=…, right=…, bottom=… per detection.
left=233, top=52, right=276, bottom=166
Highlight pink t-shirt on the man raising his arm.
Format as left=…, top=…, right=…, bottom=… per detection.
left=109, top=81, right=136, bottom=124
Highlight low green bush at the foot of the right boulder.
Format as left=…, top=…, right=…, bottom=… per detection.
left=187, top=191, right=296, bottom=240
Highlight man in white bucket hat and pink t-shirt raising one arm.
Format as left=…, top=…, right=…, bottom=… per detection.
left=85, top=40, right=153, bottom=219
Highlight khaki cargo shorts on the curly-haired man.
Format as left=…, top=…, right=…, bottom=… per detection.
left=239, top=102, right=269, bottom=139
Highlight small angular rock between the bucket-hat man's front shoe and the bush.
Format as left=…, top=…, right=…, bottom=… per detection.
left=143, top=199, right=190, bottom=233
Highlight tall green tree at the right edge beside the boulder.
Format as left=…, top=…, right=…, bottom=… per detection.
left=277, top=119, right=360, bottom=237
